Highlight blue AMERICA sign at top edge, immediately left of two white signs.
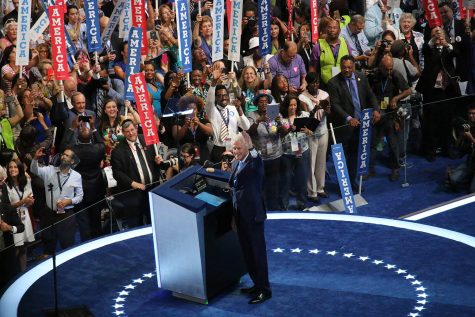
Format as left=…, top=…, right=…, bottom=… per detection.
left=176, top=0, right=192, bottom=73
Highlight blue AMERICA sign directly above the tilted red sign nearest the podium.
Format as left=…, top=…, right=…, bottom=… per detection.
left=124, top=26, right=142, bottom=101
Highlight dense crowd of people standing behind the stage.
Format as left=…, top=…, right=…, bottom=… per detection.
left=0, top=0, right=475, bottom=292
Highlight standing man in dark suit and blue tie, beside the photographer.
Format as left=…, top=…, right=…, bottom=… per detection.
left=328, top=55, right=381, bottom=189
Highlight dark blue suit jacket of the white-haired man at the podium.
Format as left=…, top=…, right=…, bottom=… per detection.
left=229, top=153, right=267, bottom=222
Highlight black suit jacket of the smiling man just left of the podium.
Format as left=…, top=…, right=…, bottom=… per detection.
left=111, top=135, right=160, bottom=191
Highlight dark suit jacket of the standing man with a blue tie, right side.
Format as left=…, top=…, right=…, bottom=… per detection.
left=328, top=72, right=379, bottom=126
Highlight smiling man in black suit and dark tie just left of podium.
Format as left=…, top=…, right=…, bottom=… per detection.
left=111, top=120, right=163, bottom=228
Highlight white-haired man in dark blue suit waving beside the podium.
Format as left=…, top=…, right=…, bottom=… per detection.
left=229, top=132, right=272, bottom=304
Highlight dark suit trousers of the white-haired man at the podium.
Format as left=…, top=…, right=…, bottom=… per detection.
left=236, top=214, right=270, bottom=290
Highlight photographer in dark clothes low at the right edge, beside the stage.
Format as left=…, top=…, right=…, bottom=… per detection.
left=446, top=104, right=475, bottom=193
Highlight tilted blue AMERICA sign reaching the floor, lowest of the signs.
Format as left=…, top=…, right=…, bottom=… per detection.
left=332, top=143, right=356, bottom=214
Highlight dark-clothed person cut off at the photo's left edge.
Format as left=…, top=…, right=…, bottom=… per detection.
left=0, top=202, right=25, bottom=290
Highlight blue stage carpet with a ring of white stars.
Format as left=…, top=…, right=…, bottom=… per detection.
left=19, top=220, right=475, bottom=317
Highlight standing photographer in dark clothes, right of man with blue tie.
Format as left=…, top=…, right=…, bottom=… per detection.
left=370, top=55, right=411, bottom=181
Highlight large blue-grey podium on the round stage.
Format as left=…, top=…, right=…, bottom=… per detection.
left=149, top=166, right=247, bottom=304
